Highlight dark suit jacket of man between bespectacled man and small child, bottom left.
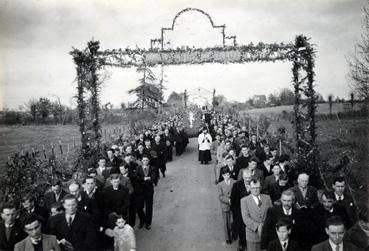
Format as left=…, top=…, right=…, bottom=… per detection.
left=48, top=211, right=97, bottom=251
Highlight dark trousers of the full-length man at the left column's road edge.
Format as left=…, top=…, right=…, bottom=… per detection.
left=137, top=192, right=154, bottom=226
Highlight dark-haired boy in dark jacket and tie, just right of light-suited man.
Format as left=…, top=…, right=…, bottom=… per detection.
left=262, top=217, right=300, bottom=251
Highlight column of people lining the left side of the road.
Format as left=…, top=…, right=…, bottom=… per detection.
left=0, top=115, right=188, bottom=251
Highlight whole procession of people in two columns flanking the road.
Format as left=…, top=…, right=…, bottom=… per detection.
left=0, top=111, right=369, bottom=251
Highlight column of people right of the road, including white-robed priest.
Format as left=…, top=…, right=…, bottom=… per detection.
left=203, top=114, right=369, bottom=251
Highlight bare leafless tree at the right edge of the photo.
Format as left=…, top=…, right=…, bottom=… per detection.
left=348, top=0, right=369, bottom=100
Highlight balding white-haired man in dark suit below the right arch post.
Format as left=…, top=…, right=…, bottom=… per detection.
left=291, top=173, right=319, bottom=209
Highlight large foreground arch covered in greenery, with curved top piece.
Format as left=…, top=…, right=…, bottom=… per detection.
left=70, top=8, right=317, bottom=169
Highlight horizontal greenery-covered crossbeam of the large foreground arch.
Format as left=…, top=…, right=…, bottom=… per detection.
left=97, top=43, right=295, bottom=68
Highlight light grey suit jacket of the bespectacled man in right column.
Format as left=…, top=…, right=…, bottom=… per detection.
left=241, top=194, right=272, bottom=242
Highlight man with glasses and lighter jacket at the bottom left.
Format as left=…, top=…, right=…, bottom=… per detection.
left=14, top=214, right=60, bottom=251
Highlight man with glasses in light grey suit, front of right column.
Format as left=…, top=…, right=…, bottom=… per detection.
left=241, top=178, right=273, bottom=251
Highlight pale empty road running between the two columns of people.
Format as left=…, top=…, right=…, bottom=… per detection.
left=136, top=139, right=237, bottom=251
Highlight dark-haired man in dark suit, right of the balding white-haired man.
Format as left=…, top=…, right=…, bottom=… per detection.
left=332, top=176, right=358, bottom=226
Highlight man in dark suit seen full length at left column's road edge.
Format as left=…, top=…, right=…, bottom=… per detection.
left=136, top=155, right=157, bottom=230
